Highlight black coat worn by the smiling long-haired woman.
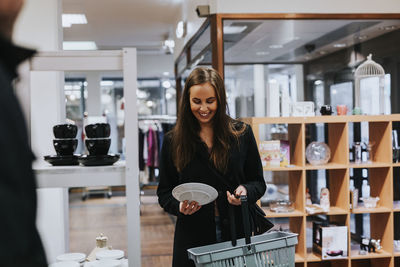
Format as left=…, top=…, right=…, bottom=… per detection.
left=157, top=125, right=266, bottom=267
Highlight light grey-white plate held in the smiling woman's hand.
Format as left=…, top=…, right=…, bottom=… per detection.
left=172, top=183, right=218, bottom=206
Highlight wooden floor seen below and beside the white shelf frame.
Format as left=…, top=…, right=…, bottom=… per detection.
left=69, top=194, right=174, bottom=267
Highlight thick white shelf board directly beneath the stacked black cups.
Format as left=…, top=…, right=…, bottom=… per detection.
left=33, top=161, right=125, bottom=188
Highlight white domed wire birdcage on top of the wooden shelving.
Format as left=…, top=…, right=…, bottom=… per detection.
left=354, top=54, right=385, bottom=114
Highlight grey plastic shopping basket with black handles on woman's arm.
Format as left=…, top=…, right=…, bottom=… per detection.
left=188, top=196, right=297, bottom=267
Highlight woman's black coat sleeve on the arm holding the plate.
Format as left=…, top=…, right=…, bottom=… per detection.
left=157, top=136, right=179, bottom=216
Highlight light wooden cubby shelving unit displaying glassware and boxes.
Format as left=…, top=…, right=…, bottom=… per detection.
left=242, top=114, right=400, bottom=267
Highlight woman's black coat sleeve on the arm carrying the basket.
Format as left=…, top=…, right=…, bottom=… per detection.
left=242, top=125, right=267, bottom=203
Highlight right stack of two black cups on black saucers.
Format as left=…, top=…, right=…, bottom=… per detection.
left=79, top=123, right=119, bottom=166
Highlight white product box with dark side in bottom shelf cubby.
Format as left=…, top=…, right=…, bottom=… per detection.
left=313, top=222, right=348, bottom=260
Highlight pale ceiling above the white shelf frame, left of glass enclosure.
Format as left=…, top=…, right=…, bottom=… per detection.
left=62, top=0, right=183, bottom=55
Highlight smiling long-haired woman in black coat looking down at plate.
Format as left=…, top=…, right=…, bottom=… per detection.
left=157, top=68, right=266, bottom=267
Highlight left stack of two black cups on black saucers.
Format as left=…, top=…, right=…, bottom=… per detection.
left=44, top=124, right=79, bottom=166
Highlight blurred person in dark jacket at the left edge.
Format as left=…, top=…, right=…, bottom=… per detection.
left=0, top=0, right=47, bottom=267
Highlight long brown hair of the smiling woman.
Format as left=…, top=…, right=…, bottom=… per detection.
left=171, top=67, right=245, bottom=173
